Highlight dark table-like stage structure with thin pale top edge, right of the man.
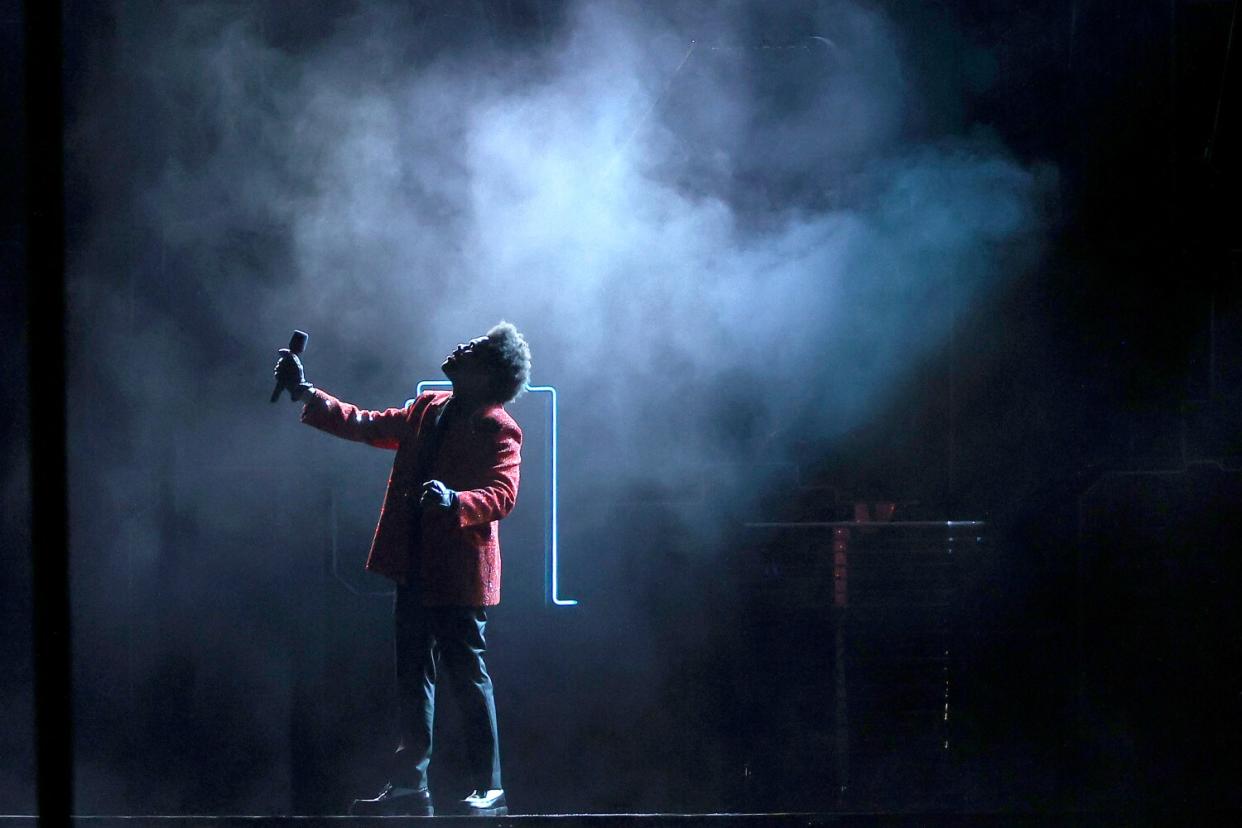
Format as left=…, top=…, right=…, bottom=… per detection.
left=744, top=518, right=987, bottom=808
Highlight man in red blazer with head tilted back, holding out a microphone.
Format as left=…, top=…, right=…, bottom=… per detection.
left=276, top=322, right=530, bottom=816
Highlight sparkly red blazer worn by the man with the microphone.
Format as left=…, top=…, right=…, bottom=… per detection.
left=302, top=389, right=522, bottom=607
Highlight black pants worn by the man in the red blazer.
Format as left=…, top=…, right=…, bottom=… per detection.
left=392, top=586, right=502, bottom=791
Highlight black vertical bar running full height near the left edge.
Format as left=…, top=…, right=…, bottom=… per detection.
left=24, top=0, right=73, bottom=826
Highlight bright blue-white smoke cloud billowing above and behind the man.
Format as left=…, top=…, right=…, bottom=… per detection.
left=83, top=2, right=1037, bottom=486
